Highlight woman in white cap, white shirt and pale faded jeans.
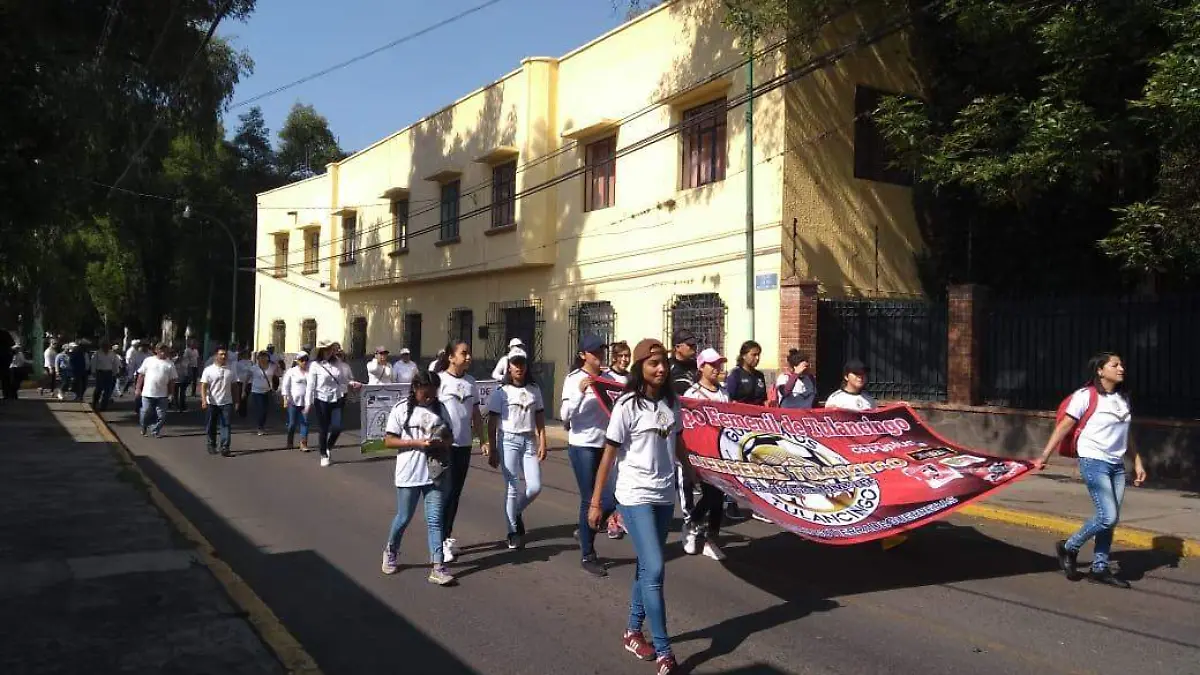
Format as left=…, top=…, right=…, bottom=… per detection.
left=487, top=350, right=546, bottom=549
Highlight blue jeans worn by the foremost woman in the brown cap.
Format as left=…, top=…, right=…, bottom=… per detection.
left=617, top=503, right=674, bottom=656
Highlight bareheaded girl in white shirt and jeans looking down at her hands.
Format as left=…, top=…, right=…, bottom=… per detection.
left=382, top=372, right=454, bottom=586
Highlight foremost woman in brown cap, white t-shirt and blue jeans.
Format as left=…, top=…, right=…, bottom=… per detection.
left=588, top=339, right=696, bottom=675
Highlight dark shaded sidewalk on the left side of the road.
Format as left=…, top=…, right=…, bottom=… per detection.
left=0, top=392, right=286, bottom=675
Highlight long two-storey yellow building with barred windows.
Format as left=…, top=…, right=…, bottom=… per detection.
left=254, top=0, right=922, bottom=394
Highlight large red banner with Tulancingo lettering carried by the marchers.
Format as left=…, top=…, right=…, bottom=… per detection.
left=595, top=381, right=1032, bottom=544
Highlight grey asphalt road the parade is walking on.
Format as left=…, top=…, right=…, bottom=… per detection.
left=98, top=393, right=1200, bottom=675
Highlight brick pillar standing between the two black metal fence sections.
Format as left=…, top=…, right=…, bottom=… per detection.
left=946, top=283, right=988, bottom=406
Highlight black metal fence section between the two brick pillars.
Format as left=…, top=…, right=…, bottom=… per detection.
left=817, top=299, right=947, bottom=400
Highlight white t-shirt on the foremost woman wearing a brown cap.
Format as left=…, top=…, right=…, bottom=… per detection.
left=605, top=393, right=683, bottom=506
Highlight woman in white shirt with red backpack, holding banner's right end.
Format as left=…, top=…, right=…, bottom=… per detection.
left=1034, top=352, right=1146, bottom=589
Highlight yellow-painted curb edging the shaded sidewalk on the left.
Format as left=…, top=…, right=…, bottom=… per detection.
left=88, top=410, right=323, bottom=675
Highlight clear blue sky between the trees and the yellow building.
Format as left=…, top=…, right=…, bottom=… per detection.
left=217, top=0, right=624, bottom=151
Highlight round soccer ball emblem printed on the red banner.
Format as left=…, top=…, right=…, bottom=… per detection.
left=720, top=429, right=880, bottom=525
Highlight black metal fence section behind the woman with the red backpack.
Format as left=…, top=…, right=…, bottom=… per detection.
left=982, top=293, right=1200, bottom=418
